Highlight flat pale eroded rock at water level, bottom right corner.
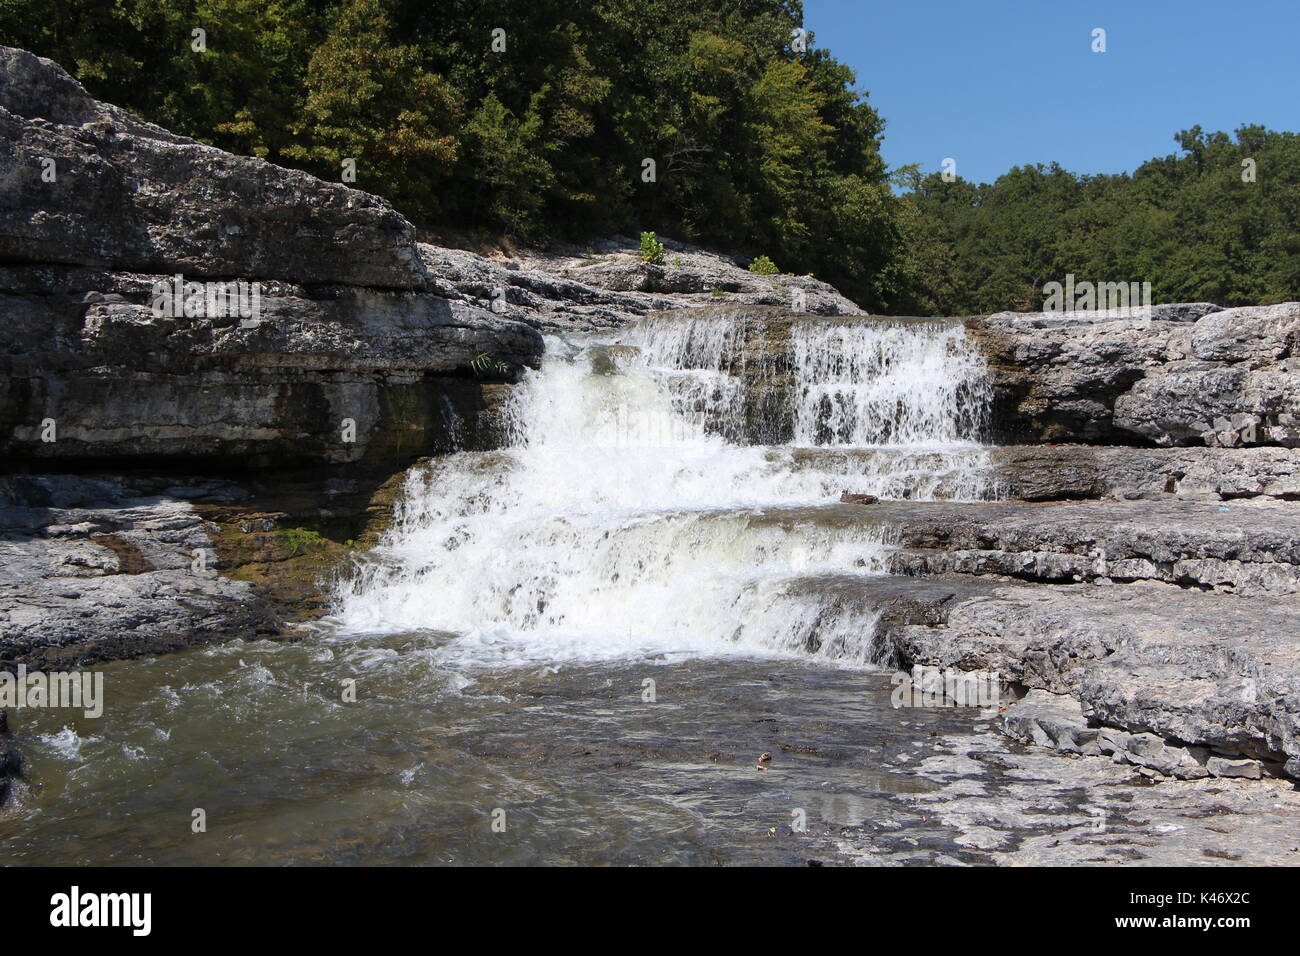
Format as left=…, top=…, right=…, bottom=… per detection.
left=863, top=728, right=1300, bottom=866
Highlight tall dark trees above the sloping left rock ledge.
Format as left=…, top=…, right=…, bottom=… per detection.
left=0, top=0, right=902, bottom=306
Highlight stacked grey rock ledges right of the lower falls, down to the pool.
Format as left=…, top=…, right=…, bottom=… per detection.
left=763, top=497, right=1300, bottom=779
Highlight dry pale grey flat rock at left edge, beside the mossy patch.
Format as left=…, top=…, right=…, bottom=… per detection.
left=0, top=475, right=278, bottom=670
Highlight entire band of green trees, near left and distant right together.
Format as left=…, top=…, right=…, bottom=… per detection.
left=0, top=0, right=1300, bottom=313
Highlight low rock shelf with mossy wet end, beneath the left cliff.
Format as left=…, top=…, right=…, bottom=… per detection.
left=0, top=472, right=404, bottom=667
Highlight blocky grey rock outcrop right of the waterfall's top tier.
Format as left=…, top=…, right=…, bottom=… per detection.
left=967, top=302, right=1300, bottom=447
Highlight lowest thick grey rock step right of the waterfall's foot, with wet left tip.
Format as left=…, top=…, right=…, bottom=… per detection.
left=790, top=575, right=1300, bottom=778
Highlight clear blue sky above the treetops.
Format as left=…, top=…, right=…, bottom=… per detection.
left=803, top=0, right=1300, bottom=182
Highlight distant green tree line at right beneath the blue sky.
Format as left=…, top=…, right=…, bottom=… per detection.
left=905, top=126, right=1300, bottom=315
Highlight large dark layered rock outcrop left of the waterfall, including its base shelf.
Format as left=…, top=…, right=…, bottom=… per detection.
left=0, top=48, right=542, bottom=669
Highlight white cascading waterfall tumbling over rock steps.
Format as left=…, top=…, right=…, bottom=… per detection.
left=335, top=313, right=988, bottom=665
